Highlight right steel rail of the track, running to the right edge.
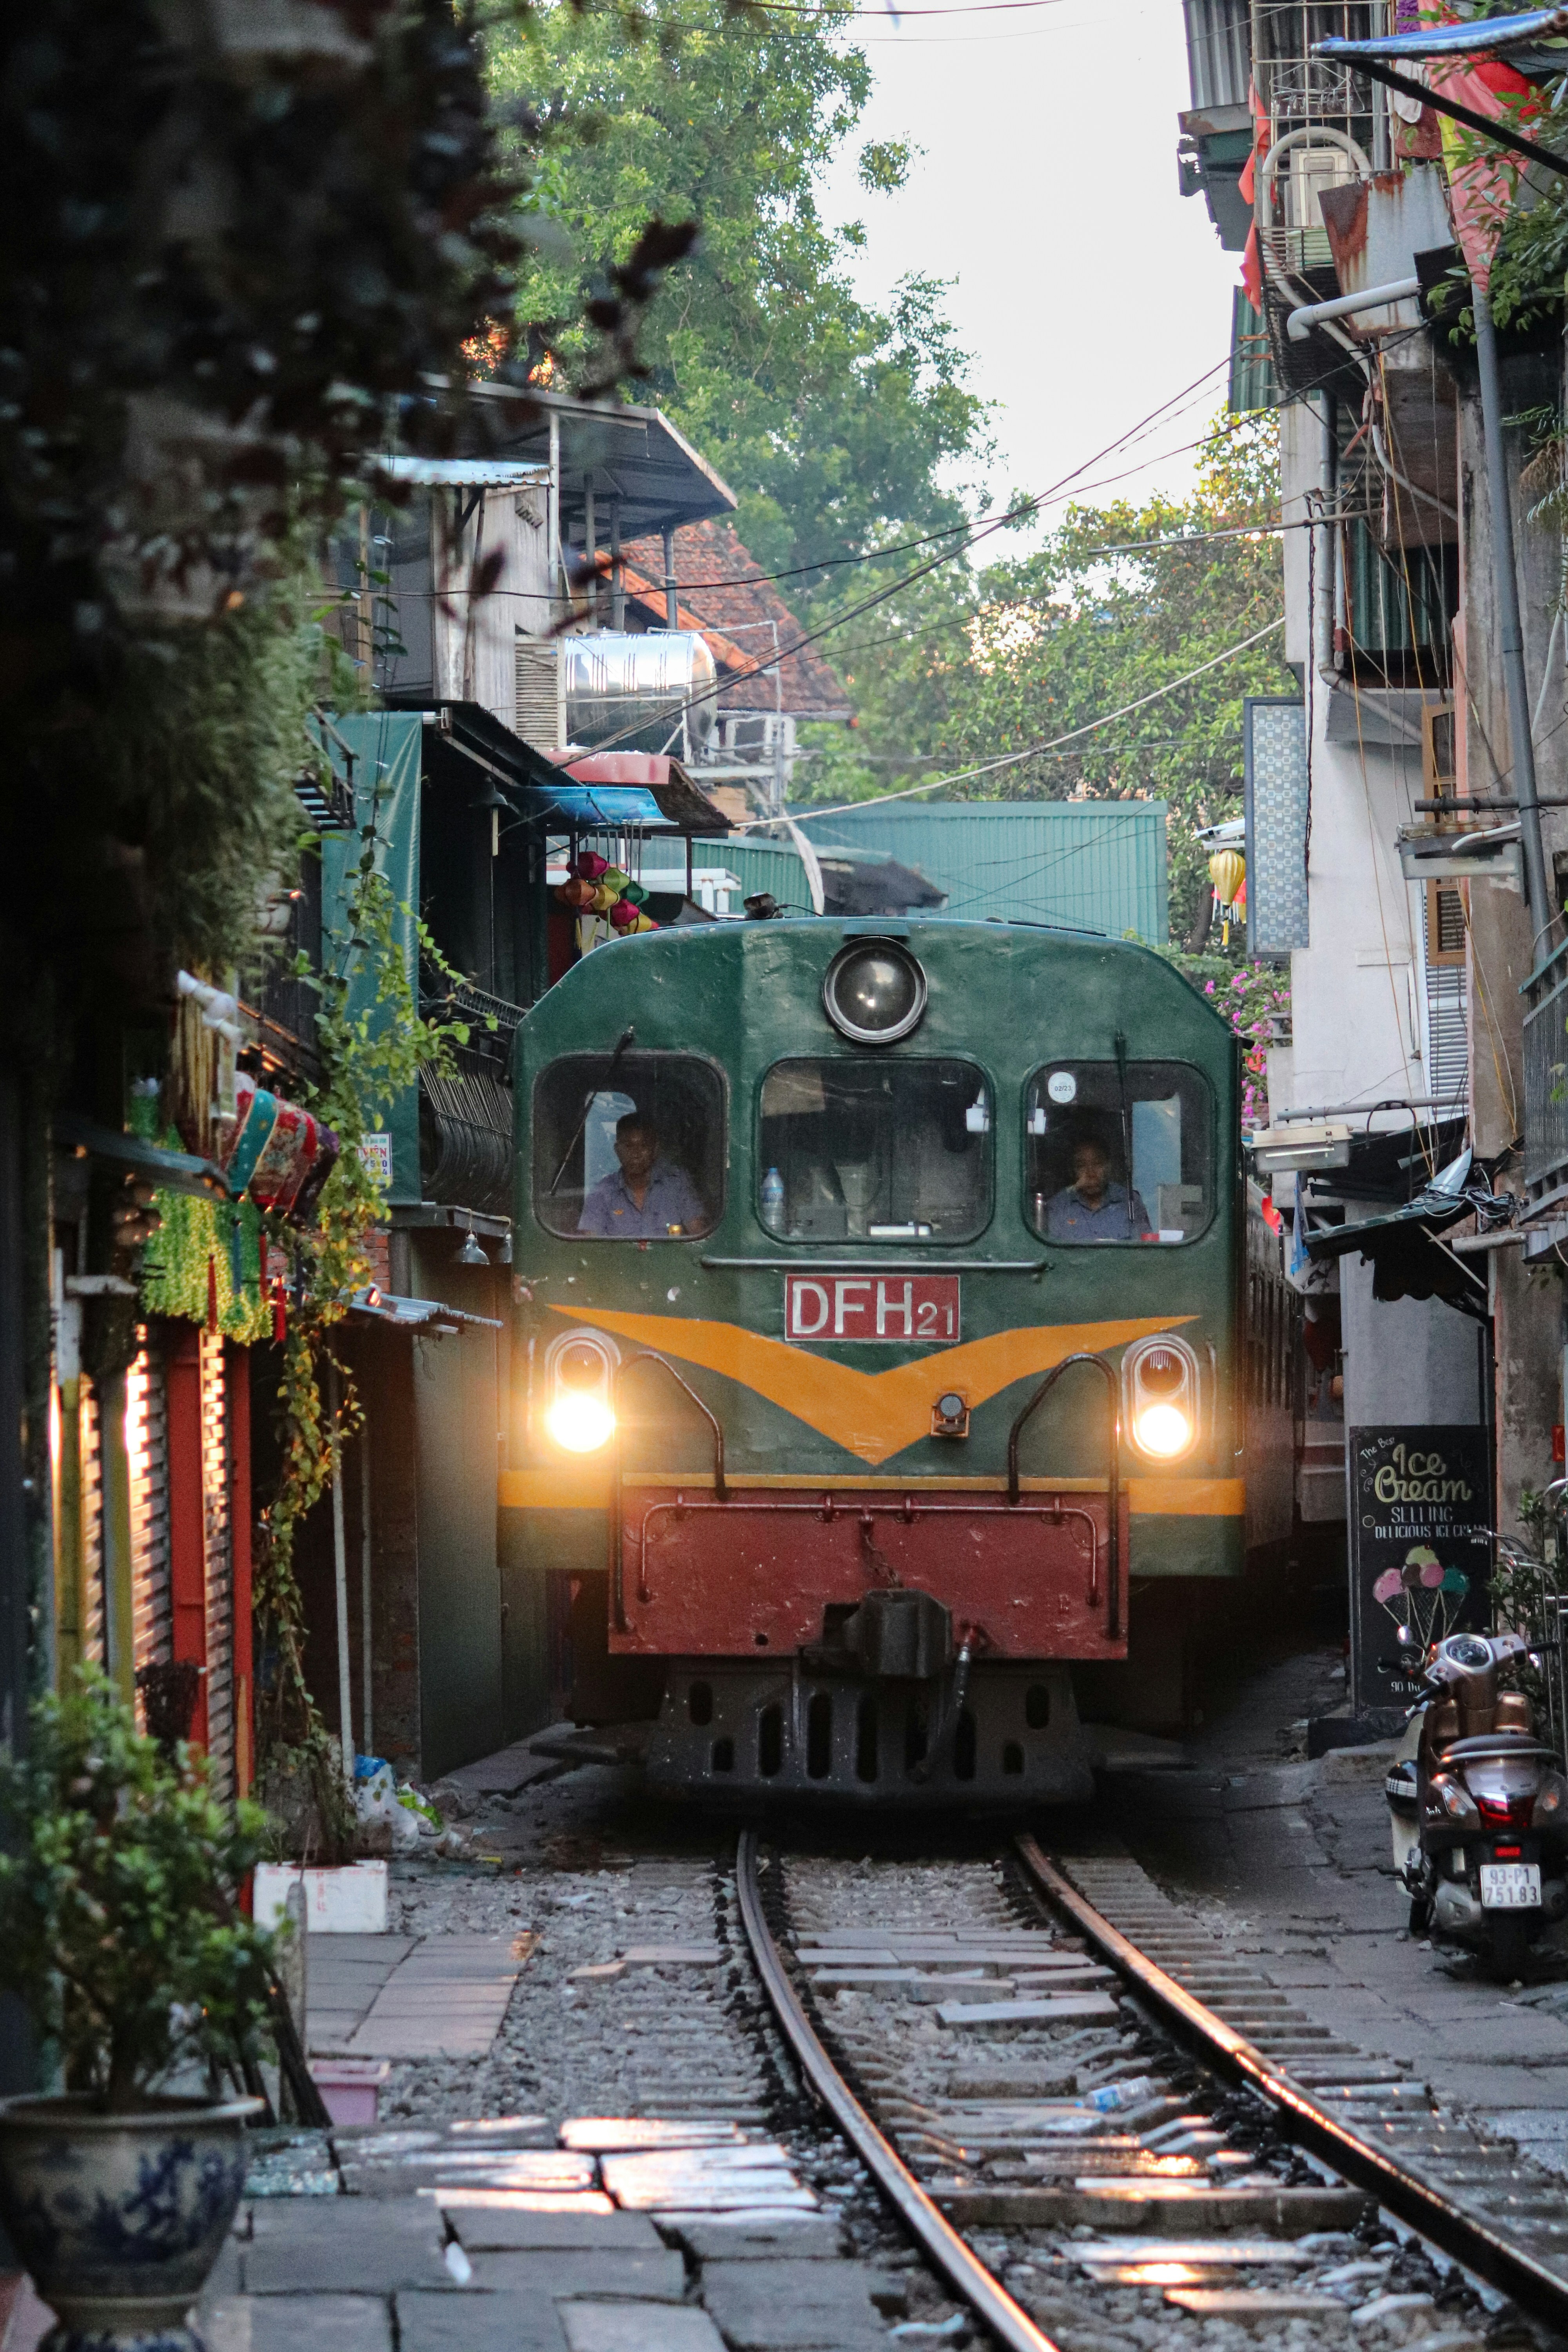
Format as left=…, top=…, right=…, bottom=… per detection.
left=1016, top=1832, right=1568, bottom=2331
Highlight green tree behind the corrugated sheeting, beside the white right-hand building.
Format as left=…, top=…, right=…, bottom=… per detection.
left=811, top=414, right=1293, bottom=934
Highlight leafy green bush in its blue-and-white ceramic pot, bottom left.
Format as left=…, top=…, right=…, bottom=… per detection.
left=0, top=1672, right=273, bottom=2352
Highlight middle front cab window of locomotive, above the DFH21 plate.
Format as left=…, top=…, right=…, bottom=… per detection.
left=757, top=1056, right=992, bottom=1242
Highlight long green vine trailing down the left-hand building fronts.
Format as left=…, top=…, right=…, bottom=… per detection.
left=254, top=800, right=479, bottom=1860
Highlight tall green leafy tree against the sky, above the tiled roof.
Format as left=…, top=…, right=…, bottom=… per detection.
left=491, top=0, right=985, bottom=567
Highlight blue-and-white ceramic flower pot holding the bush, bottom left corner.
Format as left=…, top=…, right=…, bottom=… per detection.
left=0, top=2098, right=261, bottom=2352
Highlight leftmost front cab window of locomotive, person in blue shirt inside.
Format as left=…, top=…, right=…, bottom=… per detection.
left=534, top=1054, right=724, bottom=1242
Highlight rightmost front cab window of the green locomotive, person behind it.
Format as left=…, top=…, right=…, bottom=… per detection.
left=1025, top=1061, right=1213, bottom=1247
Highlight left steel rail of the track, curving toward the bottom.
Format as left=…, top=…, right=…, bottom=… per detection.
left=736, top=1830, right=1058, bottom=2352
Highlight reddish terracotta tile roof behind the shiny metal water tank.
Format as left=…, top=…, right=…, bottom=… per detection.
left=623, top=522, right=849, bottom=717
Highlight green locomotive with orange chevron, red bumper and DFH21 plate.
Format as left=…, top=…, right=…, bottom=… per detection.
left=503, top=917, right=1243, bottom=1804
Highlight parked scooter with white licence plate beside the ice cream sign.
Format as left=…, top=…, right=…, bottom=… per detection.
left=1385, top=1632, right=1568, bottom=1983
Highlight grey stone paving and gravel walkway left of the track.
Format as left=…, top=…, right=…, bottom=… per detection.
left=0, top=1769, right=952, bottom=2352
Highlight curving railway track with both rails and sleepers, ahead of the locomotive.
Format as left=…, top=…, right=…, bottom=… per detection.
left=736, top=1830, right=1568, bottom=2352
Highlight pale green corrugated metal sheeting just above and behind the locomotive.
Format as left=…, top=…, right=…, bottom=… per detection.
left=789, top=800, right=1169, bottom=943
